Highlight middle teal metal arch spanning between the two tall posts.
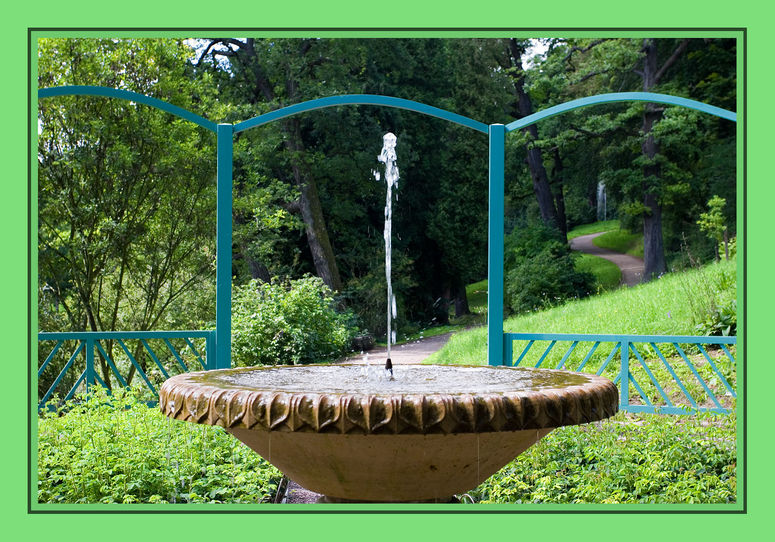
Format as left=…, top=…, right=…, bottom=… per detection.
left=234, top=94, right=489, bottom=134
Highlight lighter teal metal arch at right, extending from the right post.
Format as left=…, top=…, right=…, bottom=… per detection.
left=506, top=92, right=737, bottom=132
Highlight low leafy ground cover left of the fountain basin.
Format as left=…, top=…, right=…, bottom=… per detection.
left=37, top=389, right=282, bottom=504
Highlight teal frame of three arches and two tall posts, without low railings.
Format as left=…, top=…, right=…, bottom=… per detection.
left=38, top=86, right=737, bottom=370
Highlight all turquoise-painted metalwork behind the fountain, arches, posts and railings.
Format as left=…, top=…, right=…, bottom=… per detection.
left=38, top=86, right=737, bottom=412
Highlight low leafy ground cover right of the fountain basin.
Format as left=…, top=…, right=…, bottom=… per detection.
left=469, top=413, right=737, bottom=504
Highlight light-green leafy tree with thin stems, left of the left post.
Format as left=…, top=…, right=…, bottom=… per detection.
left=38, top=39, right=215, bottom=388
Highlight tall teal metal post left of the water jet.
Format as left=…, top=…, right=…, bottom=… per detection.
left=217, top=124, right=234, bottom=369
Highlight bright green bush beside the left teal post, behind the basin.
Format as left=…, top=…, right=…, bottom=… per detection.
left=232, top=276, right=357, bottom=367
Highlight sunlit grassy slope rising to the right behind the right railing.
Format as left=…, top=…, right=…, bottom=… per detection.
left=427, top=261, right=736, bottom=365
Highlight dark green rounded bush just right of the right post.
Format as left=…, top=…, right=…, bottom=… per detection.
left=504, top=225, right=595, bottom=314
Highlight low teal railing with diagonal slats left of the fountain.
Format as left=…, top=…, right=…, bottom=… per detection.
left=38, top=330, right=215, bottom=409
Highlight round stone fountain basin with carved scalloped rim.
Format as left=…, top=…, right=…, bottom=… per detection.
left=159, top=364, right=619, bottom=502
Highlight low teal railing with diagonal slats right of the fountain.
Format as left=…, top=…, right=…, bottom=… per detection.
left=503, top=333, right=737, bottom=414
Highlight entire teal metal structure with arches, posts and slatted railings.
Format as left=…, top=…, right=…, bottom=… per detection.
left=38, top=86, right=737, bottom=412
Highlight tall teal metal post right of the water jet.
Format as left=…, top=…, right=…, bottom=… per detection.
left=487, top=124, right=506, bottom=365
